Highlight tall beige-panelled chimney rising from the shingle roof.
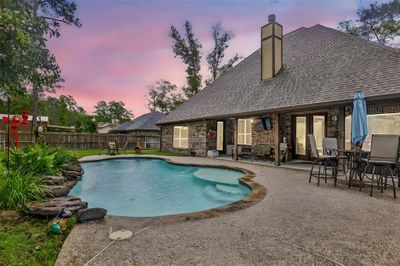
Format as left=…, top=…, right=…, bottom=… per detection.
left=261, top=14, right=283, bottom=80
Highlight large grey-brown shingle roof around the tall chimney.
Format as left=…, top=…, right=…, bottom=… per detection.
left=158, top=25, right=400, bottom=124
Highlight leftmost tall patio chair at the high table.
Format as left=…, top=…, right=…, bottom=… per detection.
left=307, top=134, right=337, bottom=187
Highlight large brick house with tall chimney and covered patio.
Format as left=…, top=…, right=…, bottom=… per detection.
left=158, top=15, right=400, bottom=164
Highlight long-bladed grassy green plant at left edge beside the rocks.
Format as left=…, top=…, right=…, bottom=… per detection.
left=0, top=169, right=45, bottom=210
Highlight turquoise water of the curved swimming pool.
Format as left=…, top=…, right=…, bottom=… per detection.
left=69, top=158, right=251, bottom=217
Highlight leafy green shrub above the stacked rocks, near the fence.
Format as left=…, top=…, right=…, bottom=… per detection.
left=10, top=145, right=59, bottom=176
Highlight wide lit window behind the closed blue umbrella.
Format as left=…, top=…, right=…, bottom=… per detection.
left=345, top=113, right=400, bottom=151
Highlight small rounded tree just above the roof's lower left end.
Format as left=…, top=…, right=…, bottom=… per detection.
left=147, top=80, right=184, bottom=114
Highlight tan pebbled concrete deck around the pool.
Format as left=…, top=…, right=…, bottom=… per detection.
left=56, top=156, right=400, bottom=265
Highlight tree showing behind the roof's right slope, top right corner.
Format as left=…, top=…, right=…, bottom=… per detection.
left=339, top=0, right=400, bottom=46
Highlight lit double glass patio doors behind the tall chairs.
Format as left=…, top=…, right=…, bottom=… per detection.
left=293, top=114, right=326, bottom=160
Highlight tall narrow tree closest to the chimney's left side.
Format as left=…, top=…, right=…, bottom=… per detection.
left=206, top=23, right=240, bottom=85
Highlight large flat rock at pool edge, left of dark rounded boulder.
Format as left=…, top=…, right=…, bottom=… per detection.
left=26, top=196, right=87, bottom=216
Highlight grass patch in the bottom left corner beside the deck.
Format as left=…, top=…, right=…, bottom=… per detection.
left=0, top=216, right=75, bottom=266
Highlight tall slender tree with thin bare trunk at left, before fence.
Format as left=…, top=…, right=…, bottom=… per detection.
left=24, top=0, right=81, bottom=135
